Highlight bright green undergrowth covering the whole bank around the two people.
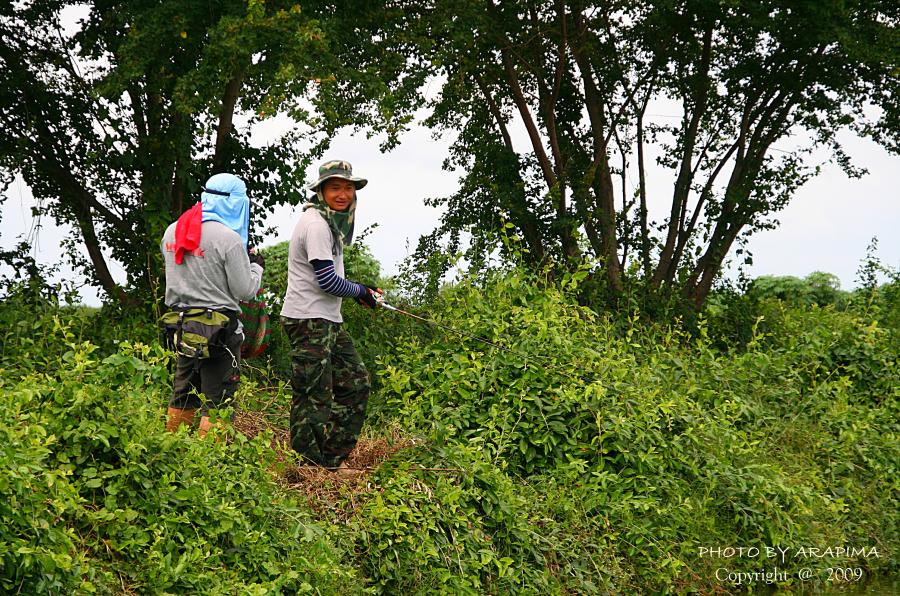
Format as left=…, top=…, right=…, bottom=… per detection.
left=0, top=268, right=900, bottom=594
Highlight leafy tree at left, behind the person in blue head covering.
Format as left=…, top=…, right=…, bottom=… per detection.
left=0, top=0, right=416, bottom=300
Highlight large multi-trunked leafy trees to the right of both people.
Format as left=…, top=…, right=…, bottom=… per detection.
left=407, top=0, right=900, bottom=307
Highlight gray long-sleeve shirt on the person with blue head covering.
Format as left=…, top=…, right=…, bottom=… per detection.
left=160, top=221, right=263, bottom=311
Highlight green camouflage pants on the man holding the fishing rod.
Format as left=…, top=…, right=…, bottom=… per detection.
left=282, top=318, right=369, bottom=467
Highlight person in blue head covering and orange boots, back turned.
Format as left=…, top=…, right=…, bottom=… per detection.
left=161, top=173, right=265, bottom=437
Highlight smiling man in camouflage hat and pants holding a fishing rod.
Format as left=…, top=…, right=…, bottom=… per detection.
left=281, top=160, right=381, bottom=473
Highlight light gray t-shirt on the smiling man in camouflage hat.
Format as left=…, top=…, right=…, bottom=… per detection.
left=281, top=208, right=344, bottom=323
